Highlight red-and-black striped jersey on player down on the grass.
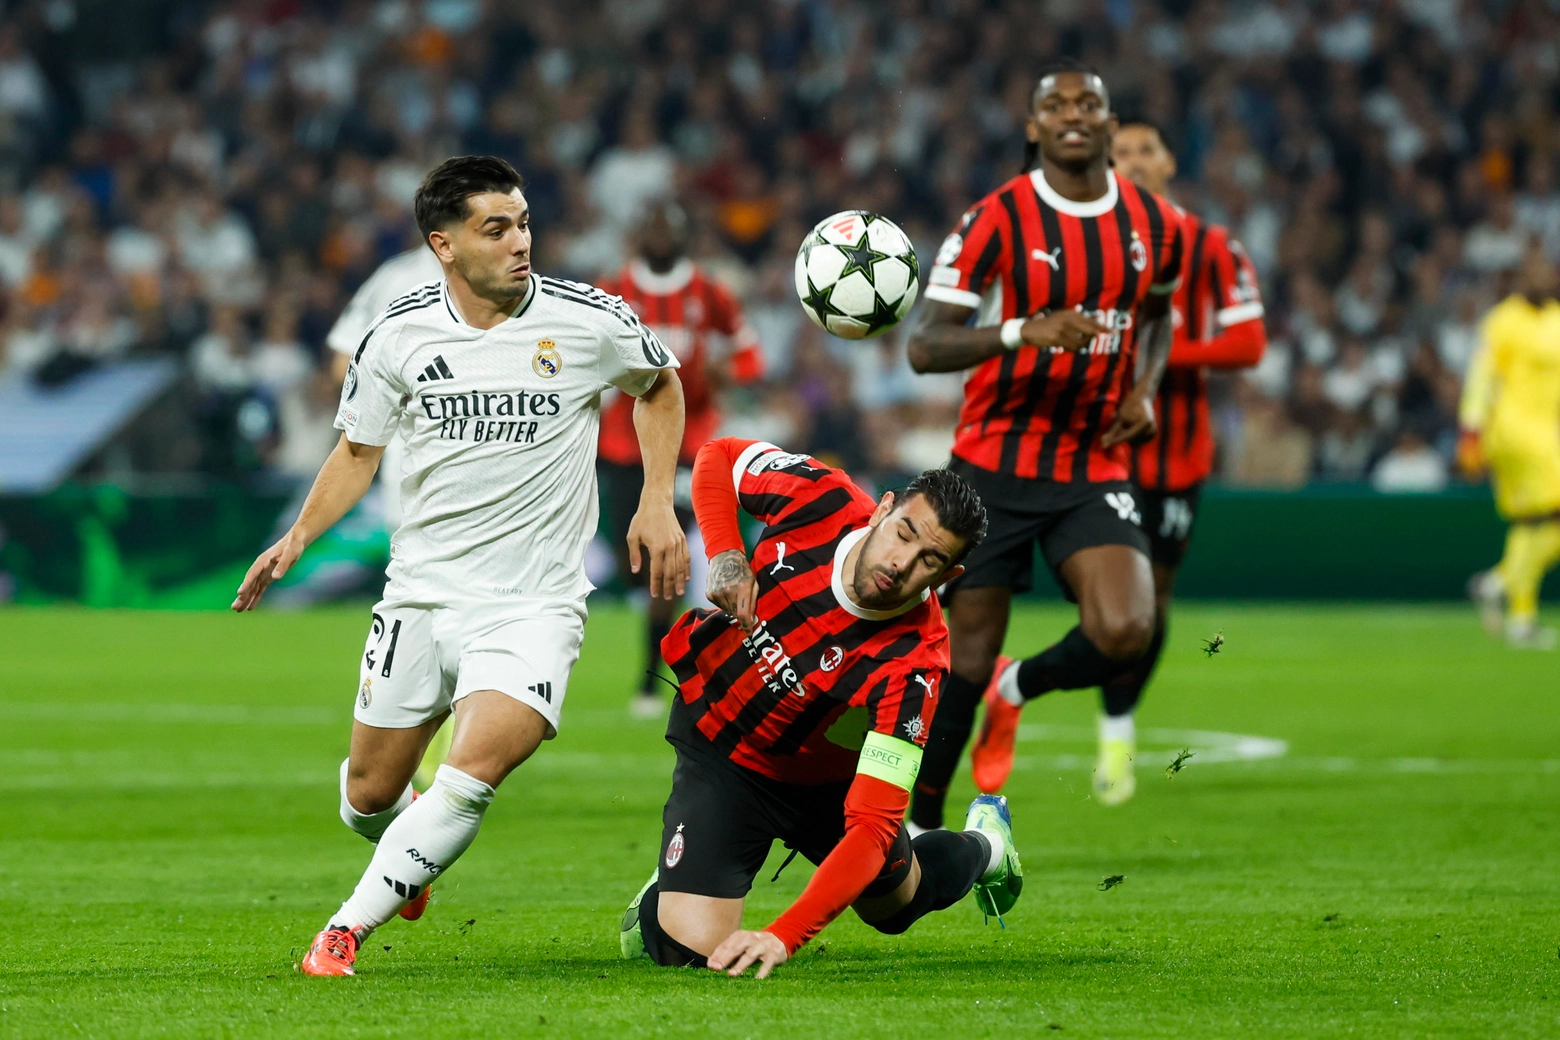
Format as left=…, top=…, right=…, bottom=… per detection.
left=661, top=443, right=948, bottom=784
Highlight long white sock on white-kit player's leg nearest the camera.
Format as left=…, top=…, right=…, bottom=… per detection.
left=331, top=766, right=493, bottom=939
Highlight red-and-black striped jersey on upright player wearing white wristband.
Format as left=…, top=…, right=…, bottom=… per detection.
left=927, top=170, right=1184, bottom=482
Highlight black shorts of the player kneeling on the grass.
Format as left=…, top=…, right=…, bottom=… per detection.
left=660, top=738, right=909, bottom=900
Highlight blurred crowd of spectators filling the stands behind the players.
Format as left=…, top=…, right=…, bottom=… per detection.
left=0, top=0, right=1560, bottom=490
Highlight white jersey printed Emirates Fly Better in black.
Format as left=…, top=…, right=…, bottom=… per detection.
left=335, top=276, right=677, bottom=608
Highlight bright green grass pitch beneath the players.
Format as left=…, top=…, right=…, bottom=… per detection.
left=0, top=605, right=1560, bottom=1040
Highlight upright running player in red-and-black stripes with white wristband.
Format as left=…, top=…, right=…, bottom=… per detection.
left=909, top=64, right=1184, bottom=828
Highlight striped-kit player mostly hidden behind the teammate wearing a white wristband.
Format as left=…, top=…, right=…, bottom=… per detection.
left=1094, top=119, right=1267, bottom=805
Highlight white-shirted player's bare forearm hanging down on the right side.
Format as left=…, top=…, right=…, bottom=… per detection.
left=629, top=368, right=690, bottom=599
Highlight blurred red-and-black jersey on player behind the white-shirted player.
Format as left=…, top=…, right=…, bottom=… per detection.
left=599, top=257, right=764, bottom=465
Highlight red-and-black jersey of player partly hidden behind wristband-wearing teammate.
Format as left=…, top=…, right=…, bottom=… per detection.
left=1133, top=210, right=1267, bottom=491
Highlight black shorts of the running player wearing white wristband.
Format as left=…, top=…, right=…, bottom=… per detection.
left=948, top=458, right=1148, bottom=602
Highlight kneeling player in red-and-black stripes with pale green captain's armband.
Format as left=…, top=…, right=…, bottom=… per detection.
left=622, top=438, right=1023, bottom=978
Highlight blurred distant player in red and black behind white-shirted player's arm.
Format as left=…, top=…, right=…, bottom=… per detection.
left=596, top=201, right=764, bottom=719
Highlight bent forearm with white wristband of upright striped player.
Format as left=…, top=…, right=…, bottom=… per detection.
left=908, top=299, right=1106, bottom=373
